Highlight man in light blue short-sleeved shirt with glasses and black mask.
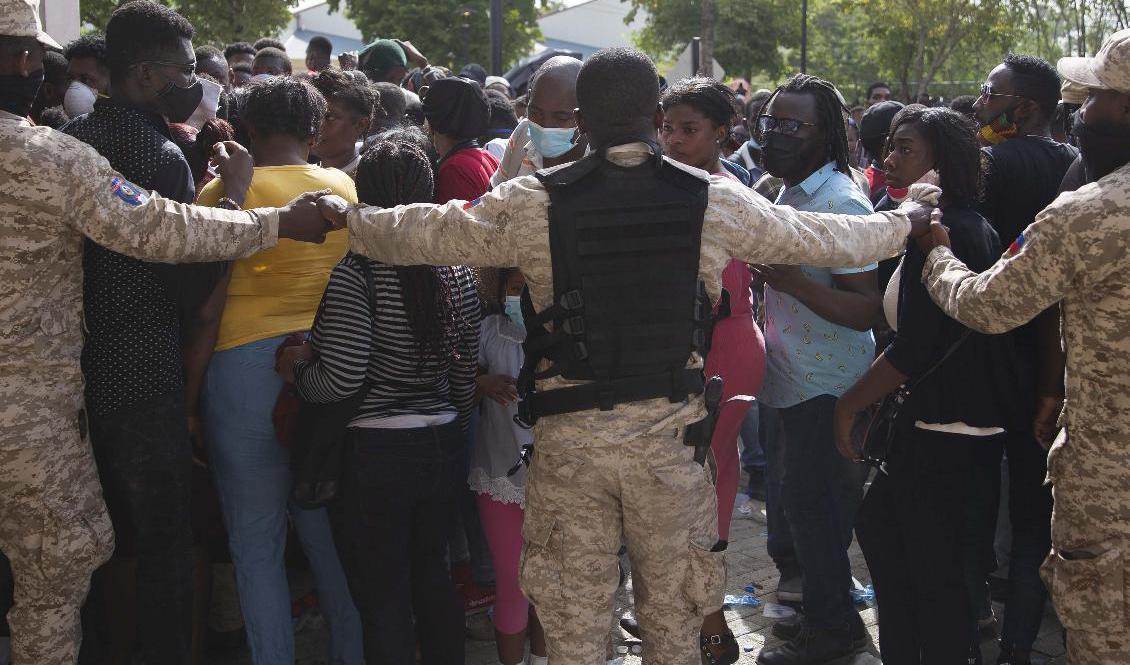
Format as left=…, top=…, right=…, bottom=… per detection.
left=756, top=75, right=880, bottom=665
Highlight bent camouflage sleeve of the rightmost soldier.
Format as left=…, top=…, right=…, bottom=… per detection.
left=922, top=195, right=1089, bottom=334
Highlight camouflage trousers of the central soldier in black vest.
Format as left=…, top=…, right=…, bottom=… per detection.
left=520, top=422, right=725, bottom=665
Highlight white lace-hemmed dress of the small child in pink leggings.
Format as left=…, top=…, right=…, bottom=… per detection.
left=467, top=314, right=533, bottom=507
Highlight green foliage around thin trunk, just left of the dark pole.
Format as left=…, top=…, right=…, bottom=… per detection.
left=624, top=0, right=800, bottom=78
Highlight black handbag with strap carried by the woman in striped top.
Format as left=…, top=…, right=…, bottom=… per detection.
left=290, top=257, right=376, bottom=509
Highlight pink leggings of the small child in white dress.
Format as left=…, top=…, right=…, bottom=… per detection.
left=476, top=494, right=528, bottom=634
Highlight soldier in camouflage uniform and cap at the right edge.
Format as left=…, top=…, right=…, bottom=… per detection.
left=920, top=31, right=1130, bottom=665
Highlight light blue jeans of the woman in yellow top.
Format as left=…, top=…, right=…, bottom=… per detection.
left=205, top=337, right=364, bottom=665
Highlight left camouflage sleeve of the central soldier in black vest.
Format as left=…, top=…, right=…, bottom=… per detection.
left=348, top=176, right=533, bottom=268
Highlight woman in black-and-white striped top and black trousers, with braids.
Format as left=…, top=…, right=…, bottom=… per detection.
left=279, top=141, right=481, bottom=665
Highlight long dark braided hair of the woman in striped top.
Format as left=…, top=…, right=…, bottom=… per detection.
left=357, top=140, right=467, bottom=364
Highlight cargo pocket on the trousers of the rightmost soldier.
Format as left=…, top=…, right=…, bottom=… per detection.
left=1041, top=543, right=1127, bottom=632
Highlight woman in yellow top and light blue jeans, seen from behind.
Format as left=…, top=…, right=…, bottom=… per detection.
left=186, top=77, right=363, bottom=665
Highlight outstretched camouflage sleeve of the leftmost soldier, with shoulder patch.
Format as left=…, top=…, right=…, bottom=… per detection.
left=63, top=146, right=278, bottom=262
